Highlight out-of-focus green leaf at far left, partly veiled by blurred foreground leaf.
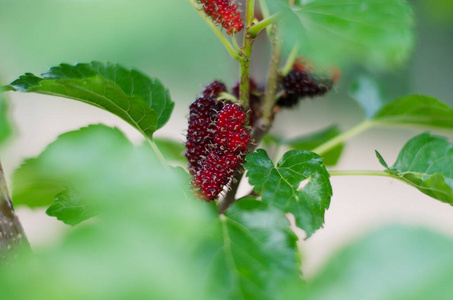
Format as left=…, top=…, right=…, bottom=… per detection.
left=12, top=125, right=128, bottom=208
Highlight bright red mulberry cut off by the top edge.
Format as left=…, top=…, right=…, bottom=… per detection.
left=198, top=0, right=244, bottom=34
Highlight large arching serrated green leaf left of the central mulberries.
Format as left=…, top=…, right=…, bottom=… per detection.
left=10, top=62, right=174, bottom=138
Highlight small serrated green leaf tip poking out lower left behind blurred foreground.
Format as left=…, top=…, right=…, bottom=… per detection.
left=46, top=190, right=98, bottom=226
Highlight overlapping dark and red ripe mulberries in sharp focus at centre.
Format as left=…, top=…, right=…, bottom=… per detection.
left=186, top=81, right=250, bottom=201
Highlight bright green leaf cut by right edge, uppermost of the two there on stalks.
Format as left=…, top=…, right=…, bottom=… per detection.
left=373, top=95, right=453, bottom=129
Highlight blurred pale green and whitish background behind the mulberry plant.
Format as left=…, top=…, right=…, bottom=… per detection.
left=0, top=0, right=453, bottom=275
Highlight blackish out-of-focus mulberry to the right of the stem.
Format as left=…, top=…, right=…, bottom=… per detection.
left=277, top=62, right=334, bottom=107
